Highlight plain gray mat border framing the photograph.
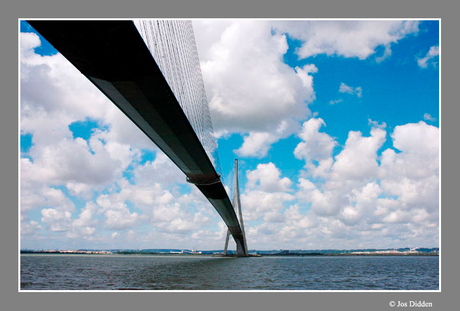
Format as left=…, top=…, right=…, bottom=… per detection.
left=0, top=0, right=460, bottom=311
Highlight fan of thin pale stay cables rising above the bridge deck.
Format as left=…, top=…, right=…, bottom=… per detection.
left=134, top=20, right=222, bottom=176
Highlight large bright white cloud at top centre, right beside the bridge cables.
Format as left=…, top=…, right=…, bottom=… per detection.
left=194, top=20, right=318, bottom=157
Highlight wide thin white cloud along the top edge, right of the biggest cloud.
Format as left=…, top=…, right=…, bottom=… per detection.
left=277, top=21, right=419, bottom=61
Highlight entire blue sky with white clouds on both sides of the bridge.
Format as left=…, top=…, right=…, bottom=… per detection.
left=18, top=19, right=440, bottom=250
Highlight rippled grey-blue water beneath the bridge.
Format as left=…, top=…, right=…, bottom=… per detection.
left=21, top=254, right=439, bottom=290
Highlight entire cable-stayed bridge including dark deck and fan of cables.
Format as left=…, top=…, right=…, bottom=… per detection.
left=28, top=20, right=248, bottom=256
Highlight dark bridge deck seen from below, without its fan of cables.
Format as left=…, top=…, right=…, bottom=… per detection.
left=28, top=20, right=248, bottom=256
